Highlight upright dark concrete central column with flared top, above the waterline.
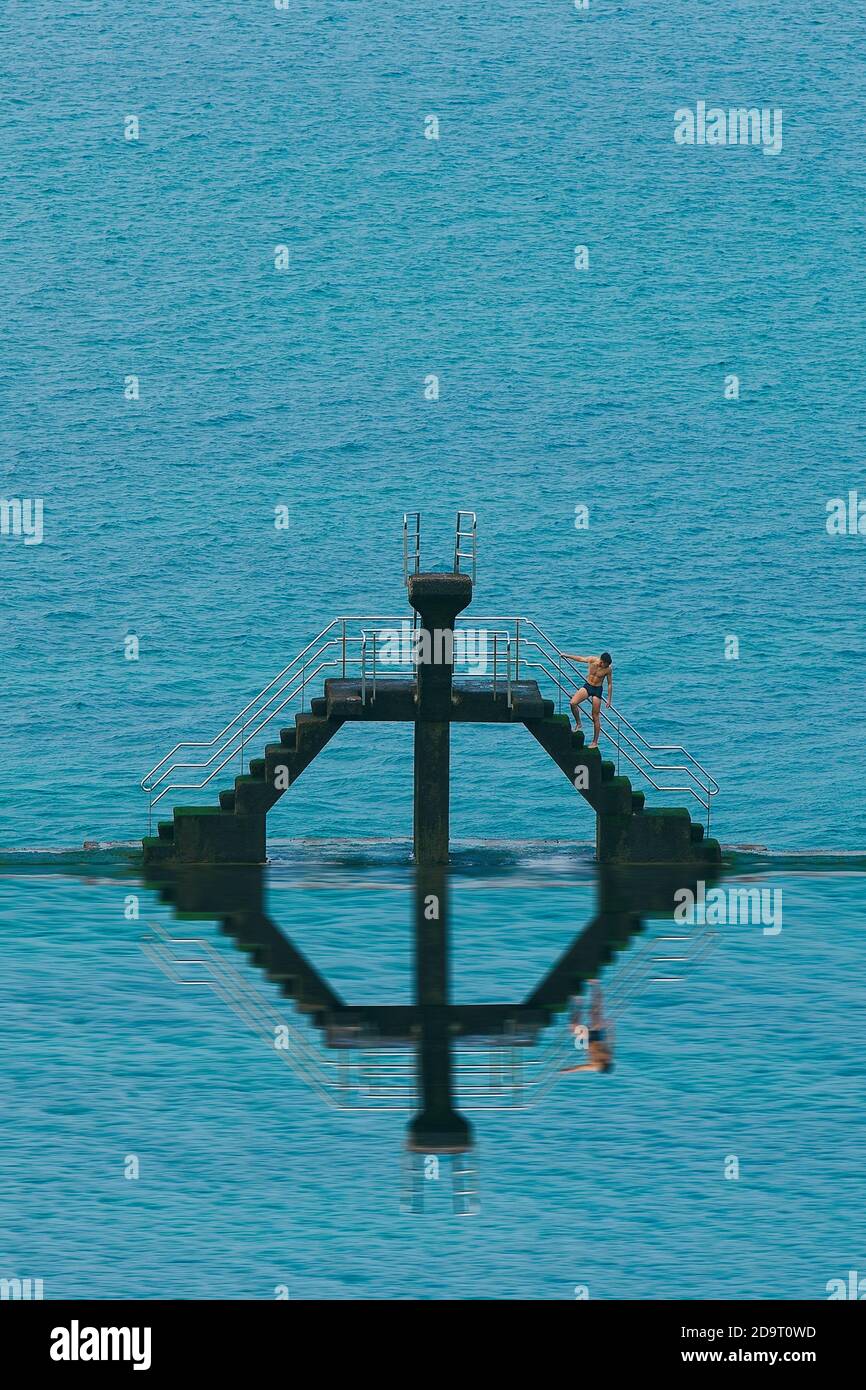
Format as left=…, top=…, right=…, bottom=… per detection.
left=409, top=574, right=473, bottom=865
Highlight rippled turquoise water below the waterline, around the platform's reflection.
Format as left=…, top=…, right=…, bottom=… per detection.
left=0, top=845, right=863, bottom=1298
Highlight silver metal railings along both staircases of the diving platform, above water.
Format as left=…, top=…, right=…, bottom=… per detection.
left=142, top=613, right=719, bottom=831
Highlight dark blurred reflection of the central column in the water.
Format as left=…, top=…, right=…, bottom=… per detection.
left=407, top=867, right=473, bottom=1154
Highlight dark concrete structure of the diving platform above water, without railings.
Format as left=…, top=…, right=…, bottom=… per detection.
left=143, top=570, right=721, bottom=866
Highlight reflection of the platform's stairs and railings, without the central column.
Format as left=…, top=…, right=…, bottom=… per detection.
left=143, top=867, right=714, bottom=1134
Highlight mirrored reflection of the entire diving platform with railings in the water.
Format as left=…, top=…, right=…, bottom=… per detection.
left=143, top=850, right=712, bottom=1209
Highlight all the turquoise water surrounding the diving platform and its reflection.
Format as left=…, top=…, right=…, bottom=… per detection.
left=0, top=0, right=866, bottom=1298
